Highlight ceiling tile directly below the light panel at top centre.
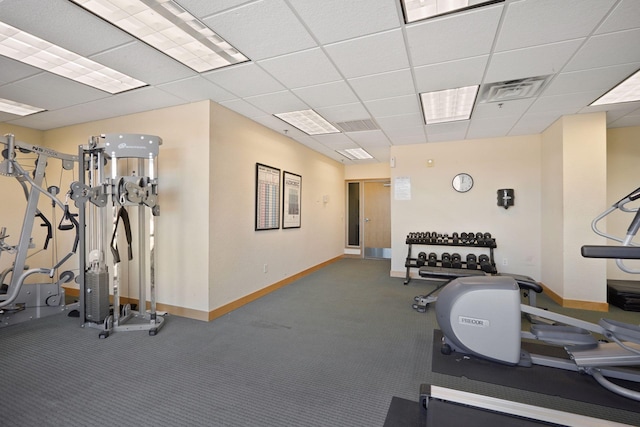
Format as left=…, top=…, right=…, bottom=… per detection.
left=406, top=5, right=503, bottom=66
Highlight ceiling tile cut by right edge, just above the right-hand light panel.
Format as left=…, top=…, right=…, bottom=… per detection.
left=564, top=28, right=640, bottom=71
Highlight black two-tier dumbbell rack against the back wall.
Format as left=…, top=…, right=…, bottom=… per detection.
left=404, top=232, right=497, bottom=285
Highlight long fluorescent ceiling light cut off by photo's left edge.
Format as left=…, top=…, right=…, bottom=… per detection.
left=0, top=22, right=146, bottom=94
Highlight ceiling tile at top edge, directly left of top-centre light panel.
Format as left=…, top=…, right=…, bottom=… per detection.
left=289, top=0, right=403, bottom=44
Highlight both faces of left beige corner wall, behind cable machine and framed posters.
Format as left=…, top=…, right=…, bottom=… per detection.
left=1, top=101, right=344, bottom=319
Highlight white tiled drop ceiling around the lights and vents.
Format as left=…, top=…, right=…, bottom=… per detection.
left=0, top=0, right=640, bottom=164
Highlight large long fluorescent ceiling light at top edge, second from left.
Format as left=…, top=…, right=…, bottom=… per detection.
left=72, top=0, right=248, bottom=73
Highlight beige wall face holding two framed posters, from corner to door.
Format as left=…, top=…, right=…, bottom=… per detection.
left=208, top=104, right=345, bottom=309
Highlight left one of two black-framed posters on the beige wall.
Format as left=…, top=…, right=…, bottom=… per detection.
left=256, top=163, right=280, bottom=231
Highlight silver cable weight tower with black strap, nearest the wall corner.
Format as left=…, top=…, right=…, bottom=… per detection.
left=71, top=134, right=164, bottom=338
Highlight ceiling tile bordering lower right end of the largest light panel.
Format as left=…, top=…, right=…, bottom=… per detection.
left=202, top=63, right=285, bottom=97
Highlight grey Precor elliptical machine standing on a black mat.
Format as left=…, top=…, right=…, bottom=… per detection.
left=436, top=188, right=640, bottom=401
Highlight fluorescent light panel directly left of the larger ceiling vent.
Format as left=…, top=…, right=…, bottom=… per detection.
left=420, top=85, right=478, bottom=125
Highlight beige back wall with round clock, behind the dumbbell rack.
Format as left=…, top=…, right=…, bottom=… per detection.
left=391, top=135, right=540, bottom=280
